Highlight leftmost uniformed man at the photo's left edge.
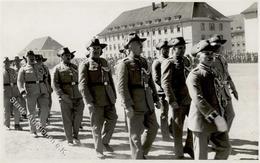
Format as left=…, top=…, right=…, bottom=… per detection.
left=3, top=57, right=22, bottom=130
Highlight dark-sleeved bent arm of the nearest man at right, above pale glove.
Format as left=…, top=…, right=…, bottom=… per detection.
left=186, top=72, right=219, bottom=122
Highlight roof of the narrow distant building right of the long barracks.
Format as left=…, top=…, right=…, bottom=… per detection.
left=228, top=14, right=245, bottom=33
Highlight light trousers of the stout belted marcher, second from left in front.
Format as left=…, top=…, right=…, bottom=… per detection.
left=25, top=94, right=49, bottom=133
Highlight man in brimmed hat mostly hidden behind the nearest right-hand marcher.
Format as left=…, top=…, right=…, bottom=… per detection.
left=209, top=35, right=238, bottom=130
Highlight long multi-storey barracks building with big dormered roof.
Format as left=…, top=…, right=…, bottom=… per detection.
left=98, top=2, right=231, bottom=57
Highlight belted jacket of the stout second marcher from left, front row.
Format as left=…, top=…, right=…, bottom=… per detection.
left=17, top=64, right=48, bottom=96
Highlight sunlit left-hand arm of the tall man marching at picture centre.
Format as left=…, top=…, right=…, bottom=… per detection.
left=117, top=62, right=134, bottom=109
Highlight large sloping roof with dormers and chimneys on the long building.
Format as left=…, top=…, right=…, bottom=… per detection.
left=98, top=2, right=229, bottom=36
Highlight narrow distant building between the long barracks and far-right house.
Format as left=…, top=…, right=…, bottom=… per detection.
left=228, top=14, right=246, bottom=54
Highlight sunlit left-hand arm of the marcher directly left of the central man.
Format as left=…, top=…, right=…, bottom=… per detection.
left=79, top=62, right=94, bottom=104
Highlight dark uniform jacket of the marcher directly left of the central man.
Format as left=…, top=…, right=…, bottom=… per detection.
left=79, top=58, right=116, bottom=106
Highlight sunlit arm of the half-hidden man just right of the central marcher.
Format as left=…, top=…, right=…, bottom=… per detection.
left=152, top=60, right=161, bottom=90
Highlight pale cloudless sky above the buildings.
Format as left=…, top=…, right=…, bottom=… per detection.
left=0, top=0, right=257, bottom=57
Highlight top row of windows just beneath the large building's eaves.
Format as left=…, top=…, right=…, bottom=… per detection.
left=104, top=25, right=181, bottom=42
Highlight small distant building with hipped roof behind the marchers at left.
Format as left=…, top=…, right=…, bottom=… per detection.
left=19, top=36, right=63, bottom=68
